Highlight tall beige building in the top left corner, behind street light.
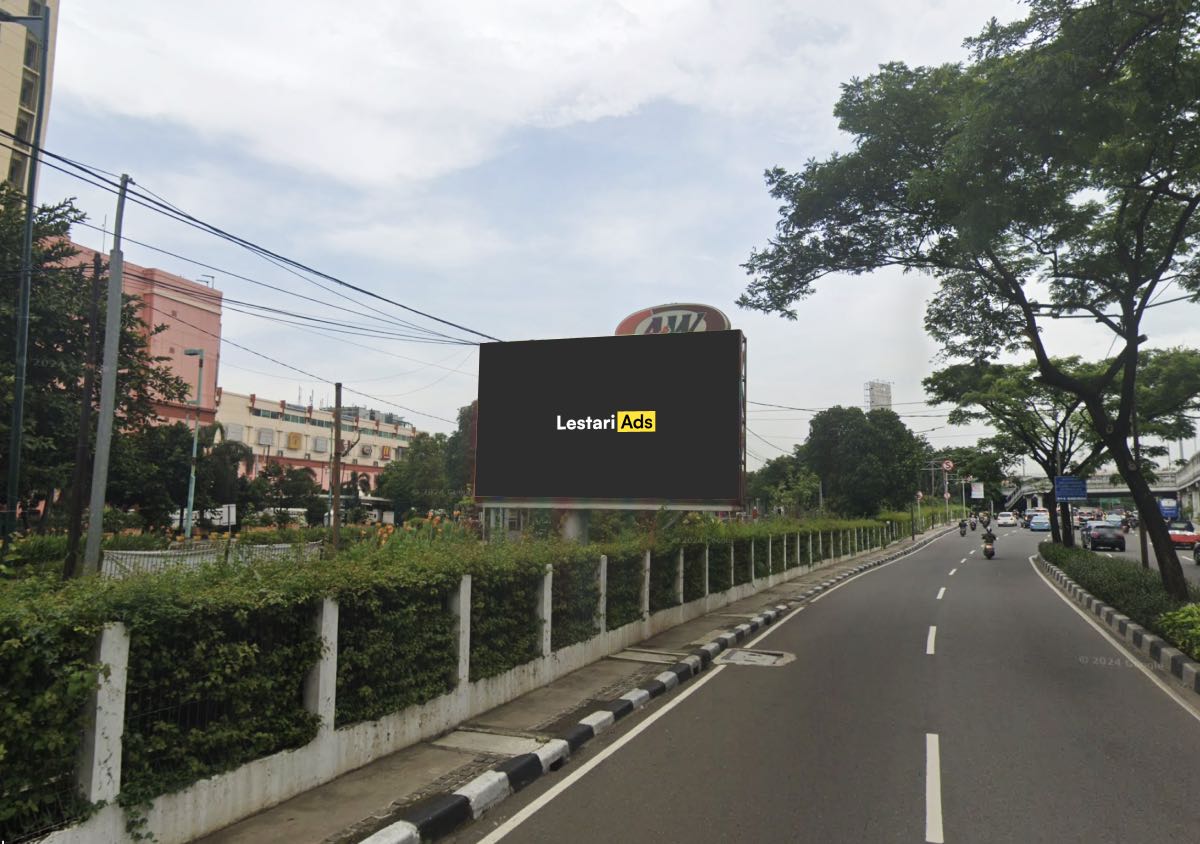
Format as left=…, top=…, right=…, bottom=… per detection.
left=0, top=0, right=59, bottom=191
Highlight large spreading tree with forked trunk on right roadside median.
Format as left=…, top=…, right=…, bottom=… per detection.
left=740, top=0, right=1200, bottom=599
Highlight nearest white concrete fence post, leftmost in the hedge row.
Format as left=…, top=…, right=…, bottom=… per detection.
left=78, top=622, right=130, bottom=802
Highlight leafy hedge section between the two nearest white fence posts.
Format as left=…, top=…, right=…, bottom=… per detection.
left=110, top=567, right=320, bottom=804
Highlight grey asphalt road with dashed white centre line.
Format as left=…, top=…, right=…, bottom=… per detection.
left=455, top=528, right=1200, bottom=844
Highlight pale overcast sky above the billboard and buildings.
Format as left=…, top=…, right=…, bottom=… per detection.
left=38, top=0, right=1196, bottom=467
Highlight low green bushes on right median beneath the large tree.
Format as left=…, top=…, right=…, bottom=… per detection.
left=1038, top=543, right=1200, bottom=639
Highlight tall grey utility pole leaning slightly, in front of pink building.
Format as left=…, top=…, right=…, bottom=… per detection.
left=83, top=173, right=130, bottom=574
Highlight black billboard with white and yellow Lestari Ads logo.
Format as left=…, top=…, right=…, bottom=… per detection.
left=475, top=331, right=745, bottom=509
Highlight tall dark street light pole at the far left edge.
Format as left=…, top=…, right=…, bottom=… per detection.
left=0, top=6, right=50, bottom=537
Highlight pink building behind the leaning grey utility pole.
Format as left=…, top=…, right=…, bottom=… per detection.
left=73, top=244, right=222, bottom=425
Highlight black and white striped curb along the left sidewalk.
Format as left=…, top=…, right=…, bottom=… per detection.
left=359, top=531, right=949, bottom=844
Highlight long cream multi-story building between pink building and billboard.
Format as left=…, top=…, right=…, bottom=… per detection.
left=216, top=389, right=416, bottom=489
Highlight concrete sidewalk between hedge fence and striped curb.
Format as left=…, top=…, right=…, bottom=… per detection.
left=198, top=528, right=941, bottom=844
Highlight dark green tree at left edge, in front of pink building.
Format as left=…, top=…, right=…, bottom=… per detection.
left=0, top=184, right=190, bottom=537
